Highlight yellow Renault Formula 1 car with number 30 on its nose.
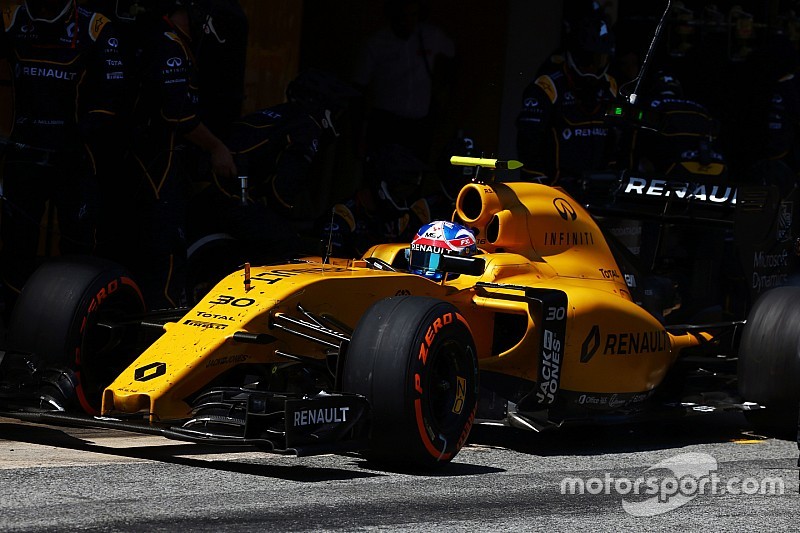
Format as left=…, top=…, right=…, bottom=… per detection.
left=0, top=158, right=800, bottom=466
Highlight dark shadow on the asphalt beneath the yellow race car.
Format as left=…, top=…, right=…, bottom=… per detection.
left=0, top=412, right=772, bottom=483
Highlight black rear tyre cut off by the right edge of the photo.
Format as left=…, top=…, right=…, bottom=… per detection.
left=738, top=287, right=800, bottom=431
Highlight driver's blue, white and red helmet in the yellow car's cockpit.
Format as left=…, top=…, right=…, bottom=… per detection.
left=408, top=220, right=478, bottom=281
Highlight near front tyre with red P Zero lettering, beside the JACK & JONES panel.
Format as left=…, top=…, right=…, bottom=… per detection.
left=343, top=296, right=478, bottom=468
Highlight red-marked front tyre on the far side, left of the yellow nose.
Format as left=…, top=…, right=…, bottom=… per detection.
left=7, top=257, right=145, bottom=414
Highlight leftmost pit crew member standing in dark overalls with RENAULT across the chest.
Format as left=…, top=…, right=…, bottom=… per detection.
left=0, top=0, right=124, bottom=314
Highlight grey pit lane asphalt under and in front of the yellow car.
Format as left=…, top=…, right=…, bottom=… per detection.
left=0, top=413, right=800, bottom=532
